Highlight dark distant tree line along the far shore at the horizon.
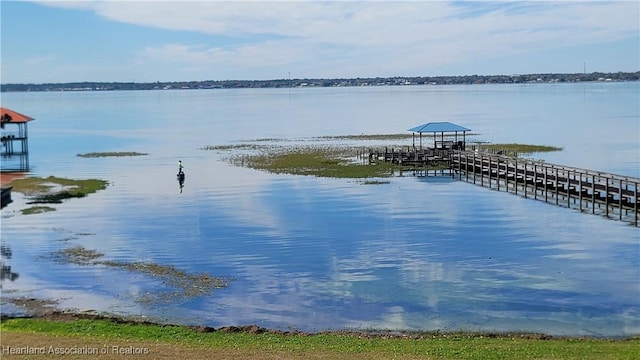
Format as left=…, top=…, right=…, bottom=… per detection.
left=0, top=71, right=640, bottom=92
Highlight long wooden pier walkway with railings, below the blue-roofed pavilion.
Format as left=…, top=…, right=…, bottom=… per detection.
left=369, top=148, right=640, bottom=227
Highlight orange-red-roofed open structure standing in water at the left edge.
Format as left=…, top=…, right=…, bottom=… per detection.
left=0, top=107, right=34, bottom=172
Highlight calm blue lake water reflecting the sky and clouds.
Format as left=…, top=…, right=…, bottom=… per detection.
left=1, top=83, right=640, bottom=336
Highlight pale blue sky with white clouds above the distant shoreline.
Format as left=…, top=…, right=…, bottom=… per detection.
left=0, top=0, right=640, bottom=83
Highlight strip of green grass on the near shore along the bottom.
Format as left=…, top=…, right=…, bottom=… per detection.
left=1, top=318, right=640, bottom=360
